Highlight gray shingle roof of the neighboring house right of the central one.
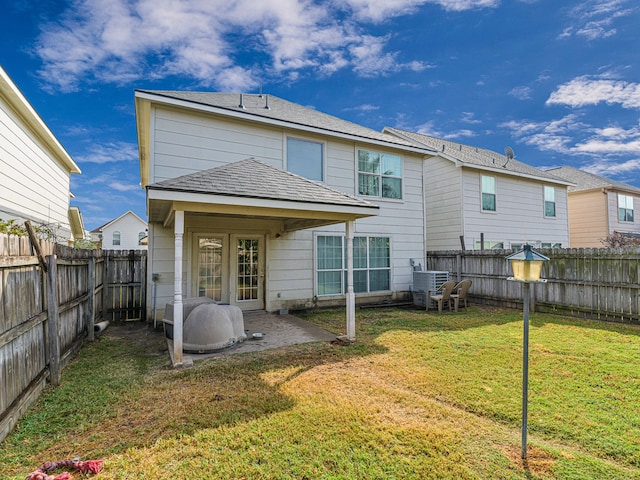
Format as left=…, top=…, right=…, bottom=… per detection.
left=384, top=127, right=571, bottom=185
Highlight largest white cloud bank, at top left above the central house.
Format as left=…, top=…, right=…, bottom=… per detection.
left=34, top=0, right=499, bottom=92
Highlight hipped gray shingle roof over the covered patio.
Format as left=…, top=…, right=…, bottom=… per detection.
left=147, top=158, right=378, bottom=209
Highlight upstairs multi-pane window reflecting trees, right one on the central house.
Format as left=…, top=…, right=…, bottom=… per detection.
left=358, top=150, right=402, bottom=199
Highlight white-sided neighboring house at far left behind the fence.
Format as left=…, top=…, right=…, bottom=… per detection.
left=0, top=67, right=84, bottom=244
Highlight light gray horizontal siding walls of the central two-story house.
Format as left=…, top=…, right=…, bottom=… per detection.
left=149, top=107, right=425, bottom=311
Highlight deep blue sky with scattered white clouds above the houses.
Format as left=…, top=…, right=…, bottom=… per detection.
left=0, top=0, right=640, bottom=229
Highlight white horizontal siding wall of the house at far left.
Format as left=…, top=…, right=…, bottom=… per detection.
left=0, top=99, right=70, bottom=239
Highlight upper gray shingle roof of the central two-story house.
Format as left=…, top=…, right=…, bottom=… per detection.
left=136, top=90, right=416, bottom=149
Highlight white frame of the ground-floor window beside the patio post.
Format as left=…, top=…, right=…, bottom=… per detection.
left=313, top=232, right=393, bottom=299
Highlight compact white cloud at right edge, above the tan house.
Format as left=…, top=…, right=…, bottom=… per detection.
left=546, top=75, right=640, bottom=108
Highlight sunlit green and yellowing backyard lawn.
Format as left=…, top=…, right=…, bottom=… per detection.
left=0, top=307, right=640, bottom=480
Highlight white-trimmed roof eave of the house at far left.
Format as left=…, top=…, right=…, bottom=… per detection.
left=0, top=66, right=81, bottom=173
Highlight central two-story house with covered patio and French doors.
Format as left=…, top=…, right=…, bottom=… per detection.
left=135, top=90, right=433, bottom=364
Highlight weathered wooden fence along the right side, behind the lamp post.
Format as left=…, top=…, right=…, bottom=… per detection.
left=426, top=248, right=640, bottom=323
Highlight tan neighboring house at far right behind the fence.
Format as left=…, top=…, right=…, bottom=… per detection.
left=548, top=167, right=640, bottom=248
